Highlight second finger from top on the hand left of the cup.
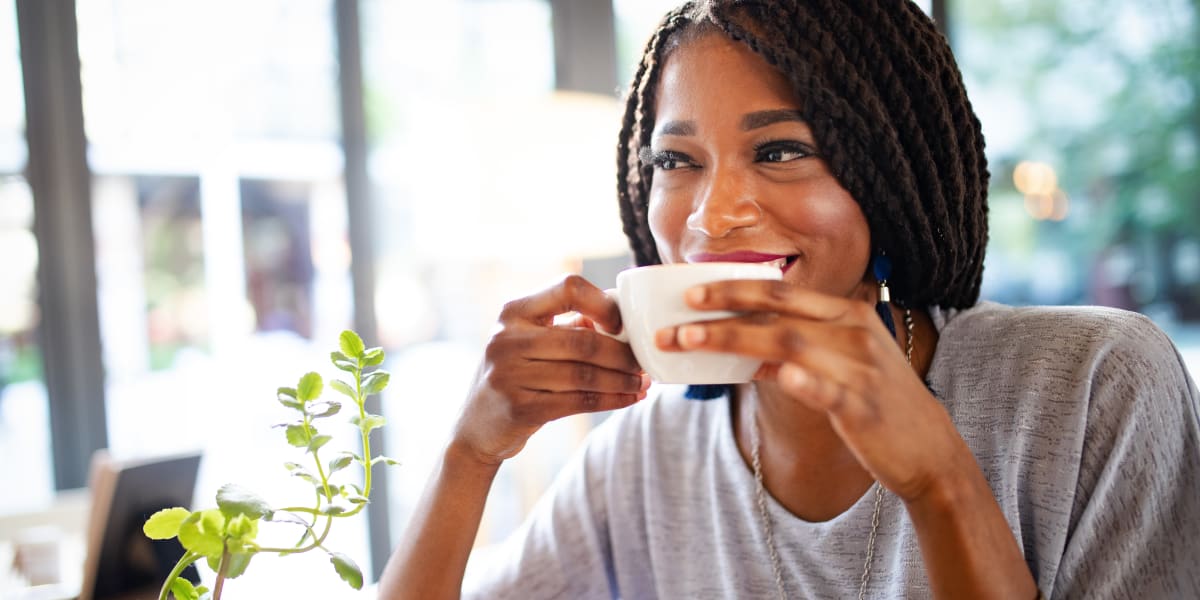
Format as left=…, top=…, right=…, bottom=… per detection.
left=504, top=328, right=642, bottom=374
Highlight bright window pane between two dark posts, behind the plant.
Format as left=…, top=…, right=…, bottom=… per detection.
left=77, top=0, right=371, bottom=590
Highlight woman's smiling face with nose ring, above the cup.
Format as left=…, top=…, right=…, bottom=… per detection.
left=643, top=34, right=872, bottom=298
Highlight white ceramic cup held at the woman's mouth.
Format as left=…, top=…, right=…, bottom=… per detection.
left=601, top=263, right=782, bottom=384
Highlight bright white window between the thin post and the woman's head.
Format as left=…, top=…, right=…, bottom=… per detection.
left=362, top=0, right=625, bottom=542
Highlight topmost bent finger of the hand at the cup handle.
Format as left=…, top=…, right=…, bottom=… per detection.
left=500, top=275, right=620, bottom=331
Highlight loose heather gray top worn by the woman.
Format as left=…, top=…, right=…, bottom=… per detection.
left=468, top=304, right=1200, bottom=599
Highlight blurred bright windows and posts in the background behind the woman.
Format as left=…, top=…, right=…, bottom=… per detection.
left=0, top=0, right=1200, bottom=596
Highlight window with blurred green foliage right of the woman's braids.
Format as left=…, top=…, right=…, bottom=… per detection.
left=952, top=0, right=1200, bottom=373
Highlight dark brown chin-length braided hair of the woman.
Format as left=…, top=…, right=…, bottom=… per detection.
left=617, top=0, right=989, bottom=307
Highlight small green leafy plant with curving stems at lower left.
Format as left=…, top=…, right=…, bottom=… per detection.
left=142, top=330, right=396, bottom=600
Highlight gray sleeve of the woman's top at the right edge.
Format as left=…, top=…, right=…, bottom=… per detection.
left=1045, top=313, right=1200, bottom=599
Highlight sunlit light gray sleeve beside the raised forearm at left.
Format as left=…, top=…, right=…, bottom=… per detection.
left=463, top=418, right=616, bottom=600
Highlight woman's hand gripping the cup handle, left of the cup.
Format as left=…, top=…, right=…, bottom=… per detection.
left=454, top=275, right=650, bottom=464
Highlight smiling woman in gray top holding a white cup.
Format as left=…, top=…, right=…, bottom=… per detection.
left=382, top=0, right=1200, bottom=599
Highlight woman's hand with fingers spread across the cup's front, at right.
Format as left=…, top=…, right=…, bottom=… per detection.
left=655, top=281, right=978, bottom=502
